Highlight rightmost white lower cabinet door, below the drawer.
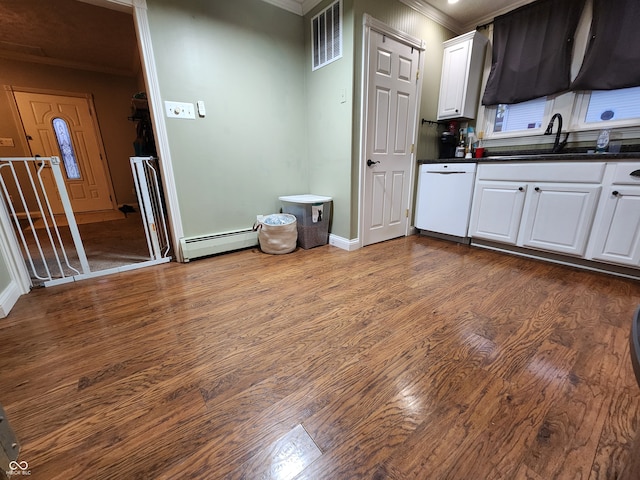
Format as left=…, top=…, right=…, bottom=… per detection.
left=593, top=185, right=640, bottom=267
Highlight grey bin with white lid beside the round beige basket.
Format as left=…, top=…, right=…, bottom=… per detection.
left=279, top=194, right=332, bottom=249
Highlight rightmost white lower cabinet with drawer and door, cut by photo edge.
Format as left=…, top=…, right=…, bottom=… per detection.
left=590, top=162, right=640, bottom=267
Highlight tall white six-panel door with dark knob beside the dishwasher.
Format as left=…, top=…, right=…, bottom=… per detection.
left=362, top=30, right=420, bottom=245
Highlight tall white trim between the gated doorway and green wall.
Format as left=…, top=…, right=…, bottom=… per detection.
left=131, top=0, right=184, bottom=262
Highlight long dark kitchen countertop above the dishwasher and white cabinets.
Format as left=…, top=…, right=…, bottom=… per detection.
left=418, top=152, right=640, bottom=165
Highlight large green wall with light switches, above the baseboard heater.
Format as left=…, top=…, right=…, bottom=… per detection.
left=147, top=0, right=309, bottom=237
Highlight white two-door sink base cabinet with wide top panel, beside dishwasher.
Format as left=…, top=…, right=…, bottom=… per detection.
left=469, top=162, right=605, bottom=256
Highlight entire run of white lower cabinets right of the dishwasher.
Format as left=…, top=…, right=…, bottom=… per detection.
left=469, top=160, right=640, bottom=274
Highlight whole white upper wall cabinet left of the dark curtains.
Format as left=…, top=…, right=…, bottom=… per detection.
left=438, top=30, right=488, bottom=120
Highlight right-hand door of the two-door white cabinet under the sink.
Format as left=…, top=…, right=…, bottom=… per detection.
left=518, top=184, right=601, bottom=256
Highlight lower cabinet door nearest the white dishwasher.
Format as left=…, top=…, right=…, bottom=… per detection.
left=469, top=181, right=527, bottom=245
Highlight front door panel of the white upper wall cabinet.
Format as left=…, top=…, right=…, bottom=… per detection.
left=438, top=40, right=471, bottom=119
